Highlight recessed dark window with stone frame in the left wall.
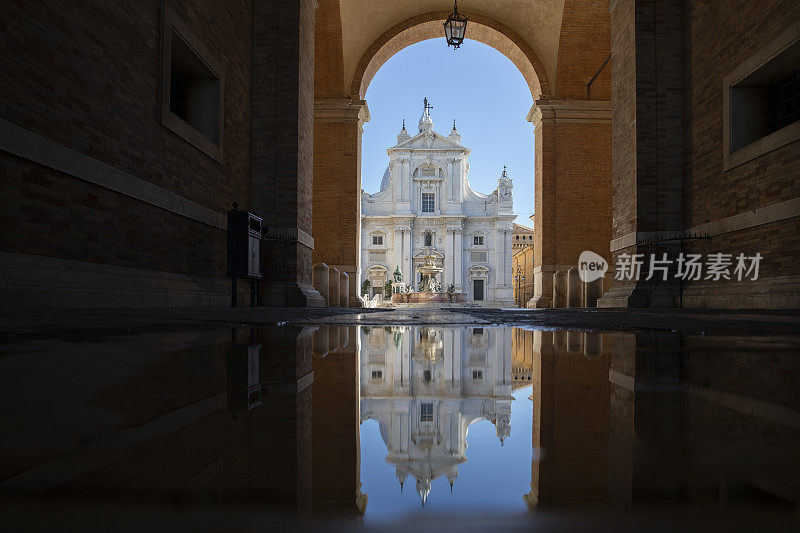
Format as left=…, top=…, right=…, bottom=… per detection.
left=161, top=7, right=225, bottom=163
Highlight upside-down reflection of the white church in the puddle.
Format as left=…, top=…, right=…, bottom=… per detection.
left=360, top=326, right=513, bottom=505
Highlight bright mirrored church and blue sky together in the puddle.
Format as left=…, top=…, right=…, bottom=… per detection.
left=360, top=326, right=532, bottom=519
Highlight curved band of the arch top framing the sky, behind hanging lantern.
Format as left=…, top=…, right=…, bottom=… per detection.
left=350, top=11, right=550, bottom=100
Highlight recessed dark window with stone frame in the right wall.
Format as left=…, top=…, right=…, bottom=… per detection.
left=724, top=30, right=800, bottom=170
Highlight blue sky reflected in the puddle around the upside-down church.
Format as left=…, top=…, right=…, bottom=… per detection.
left=361, top=386, right=533, bottom=521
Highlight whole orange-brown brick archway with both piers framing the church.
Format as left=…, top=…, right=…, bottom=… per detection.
left=313, top=0, right=611, bottom=307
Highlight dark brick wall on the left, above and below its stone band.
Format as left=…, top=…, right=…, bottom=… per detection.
left=0, top=0, right=251, bottom=290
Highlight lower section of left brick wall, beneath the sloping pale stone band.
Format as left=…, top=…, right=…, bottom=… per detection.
left=0, top=153, right=226, bottom=277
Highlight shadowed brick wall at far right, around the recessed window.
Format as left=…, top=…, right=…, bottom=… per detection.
left=683, top=0, right=800, bottom=307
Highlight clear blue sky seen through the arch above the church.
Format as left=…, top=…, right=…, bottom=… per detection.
left=361, top=37, right=534, bottom=226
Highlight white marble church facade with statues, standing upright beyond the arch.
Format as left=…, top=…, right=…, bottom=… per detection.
left=359, top=99, right=514, bottom=306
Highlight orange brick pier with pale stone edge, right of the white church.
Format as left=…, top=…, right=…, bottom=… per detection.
left=527, top=99, right=612, bottom=308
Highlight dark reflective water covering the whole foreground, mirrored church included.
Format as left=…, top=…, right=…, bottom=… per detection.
left=0, top=318, right=800, bottom=531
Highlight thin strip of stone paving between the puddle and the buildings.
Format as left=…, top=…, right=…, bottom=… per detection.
left=0, top=307, right=800, bottom=338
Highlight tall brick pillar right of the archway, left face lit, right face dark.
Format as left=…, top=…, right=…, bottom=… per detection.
left=598, top=0, right=683, bottom=307
